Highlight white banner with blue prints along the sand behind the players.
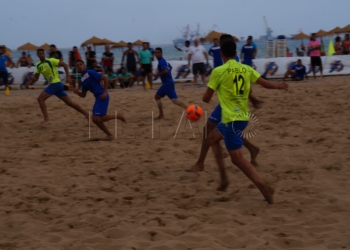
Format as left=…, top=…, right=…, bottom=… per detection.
left=0, top=55, right=350, bottom=86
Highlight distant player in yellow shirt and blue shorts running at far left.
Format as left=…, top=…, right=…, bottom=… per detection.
left=31, top=49, right=89, bottom=127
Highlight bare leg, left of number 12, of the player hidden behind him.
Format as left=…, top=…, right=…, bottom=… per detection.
left=186, top=104, right=221, bottom=172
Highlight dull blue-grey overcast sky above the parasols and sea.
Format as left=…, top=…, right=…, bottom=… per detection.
left=0, top=0, right=350, bottom=49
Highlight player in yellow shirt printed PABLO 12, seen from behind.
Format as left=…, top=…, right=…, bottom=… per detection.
left=203, top=41, right=288, bottom=204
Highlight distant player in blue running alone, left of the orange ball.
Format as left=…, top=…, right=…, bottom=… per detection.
left=153, top=47, right=187, bottom=119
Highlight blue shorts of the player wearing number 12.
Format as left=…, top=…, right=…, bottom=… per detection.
left=216, top=121, right=248, bottom=151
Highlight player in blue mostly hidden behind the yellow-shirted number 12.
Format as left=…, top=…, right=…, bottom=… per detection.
left=186, top=34, right=262, bottom=172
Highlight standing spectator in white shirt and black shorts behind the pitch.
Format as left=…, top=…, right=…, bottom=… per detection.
left=188, top=38, right=209, bottom=85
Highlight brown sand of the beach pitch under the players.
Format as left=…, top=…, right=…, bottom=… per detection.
left=0, top=76, right=350, bottom=250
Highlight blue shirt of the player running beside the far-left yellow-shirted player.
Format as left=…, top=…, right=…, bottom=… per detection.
left=81, top=69, right=105, bottom=97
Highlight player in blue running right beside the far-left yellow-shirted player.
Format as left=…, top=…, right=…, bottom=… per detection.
left=74, top=60, right=126, bottom=140
